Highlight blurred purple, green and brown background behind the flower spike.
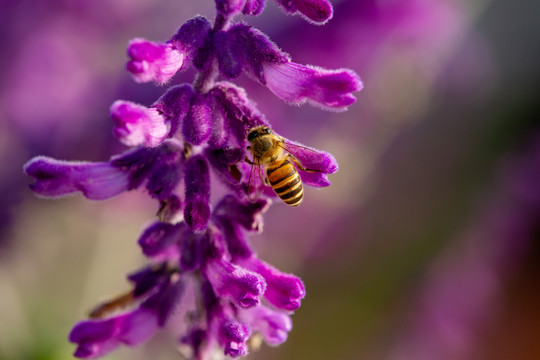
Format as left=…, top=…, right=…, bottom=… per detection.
left=0, top=0, right=540, bottom=360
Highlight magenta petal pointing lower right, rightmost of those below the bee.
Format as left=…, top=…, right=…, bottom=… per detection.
left=238, top=256, right=306, bottom=311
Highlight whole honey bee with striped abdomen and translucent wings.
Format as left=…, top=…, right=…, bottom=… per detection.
left=246, top=125, right=322, bottom=206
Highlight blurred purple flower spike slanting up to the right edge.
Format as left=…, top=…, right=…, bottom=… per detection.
left=388, top=134, right=540, bottom=360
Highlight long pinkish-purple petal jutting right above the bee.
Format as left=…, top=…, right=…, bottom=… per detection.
left=263, top=62, right=363, bottom=111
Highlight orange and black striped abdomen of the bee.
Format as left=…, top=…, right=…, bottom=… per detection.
left=266, top=159, right=304, bottom=206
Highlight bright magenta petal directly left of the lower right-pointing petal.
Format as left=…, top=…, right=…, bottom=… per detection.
left=204, top=258, right=266, bottom=308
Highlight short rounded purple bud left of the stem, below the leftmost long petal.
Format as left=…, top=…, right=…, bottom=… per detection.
left=138, top=222, right=185, bottom=259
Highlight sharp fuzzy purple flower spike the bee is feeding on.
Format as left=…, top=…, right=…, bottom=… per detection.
left=24, top=0, right=362, bottom=359
